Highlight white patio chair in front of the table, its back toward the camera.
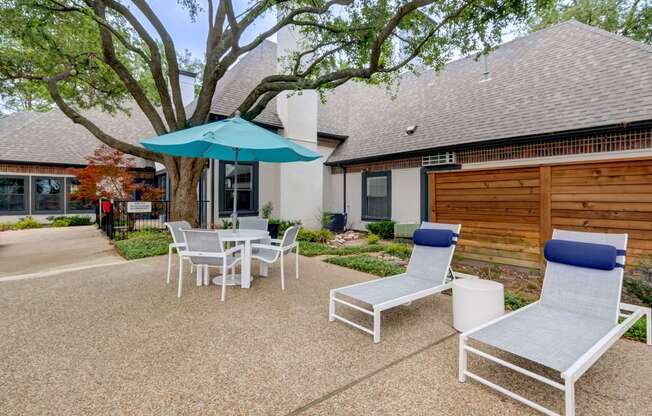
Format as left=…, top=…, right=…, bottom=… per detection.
left=177, top=230, right=242, bottom=302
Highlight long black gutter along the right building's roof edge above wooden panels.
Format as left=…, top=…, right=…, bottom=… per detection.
left=324, top=120, right=652, bottom=166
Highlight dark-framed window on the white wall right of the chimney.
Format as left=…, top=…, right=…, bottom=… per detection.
left=362, top=172, right=392, bottom=220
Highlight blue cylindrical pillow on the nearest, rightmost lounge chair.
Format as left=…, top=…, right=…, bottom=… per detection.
left=543, top=240, right=625, bottom=270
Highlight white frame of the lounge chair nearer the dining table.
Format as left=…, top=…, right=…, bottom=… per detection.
left=328, top=222, right=461, bottom=343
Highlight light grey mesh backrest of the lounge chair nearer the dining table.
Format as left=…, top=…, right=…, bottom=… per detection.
left=406, top=222, right=462, bottom=284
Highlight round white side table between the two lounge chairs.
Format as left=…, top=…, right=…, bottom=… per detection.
left=453, top=279, right=505, bottom=332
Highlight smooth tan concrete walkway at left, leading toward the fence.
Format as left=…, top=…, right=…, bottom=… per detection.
left=0, top=226, right=124, bottom=278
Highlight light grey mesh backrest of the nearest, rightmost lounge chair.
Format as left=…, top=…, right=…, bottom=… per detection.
left=541, top=230, right=627, bottom=323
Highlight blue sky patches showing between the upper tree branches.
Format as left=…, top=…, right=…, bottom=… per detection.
left=141, top=0, right=276, bottom=58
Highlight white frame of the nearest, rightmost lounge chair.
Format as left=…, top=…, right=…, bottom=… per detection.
left=459, top=231, right=652, bottom=416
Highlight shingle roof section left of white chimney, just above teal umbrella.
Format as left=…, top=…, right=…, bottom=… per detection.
left=211, top=40, right=283, bottom=127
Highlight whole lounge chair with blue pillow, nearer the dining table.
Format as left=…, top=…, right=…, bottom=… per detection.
left=328, top=222, right=460, bottom=343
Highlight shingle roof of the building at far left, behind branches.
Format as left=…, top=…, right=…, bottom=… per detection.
left=0, top=108, right=154, bottom=168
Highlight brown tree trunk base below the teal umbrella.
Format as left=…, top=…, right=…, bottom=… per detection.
left=165, top=156, right=205, bottom=227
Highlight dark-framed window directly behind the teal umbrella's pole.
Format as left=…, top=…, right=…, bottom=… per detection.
left=219, top=161, right=258, bottom=217
